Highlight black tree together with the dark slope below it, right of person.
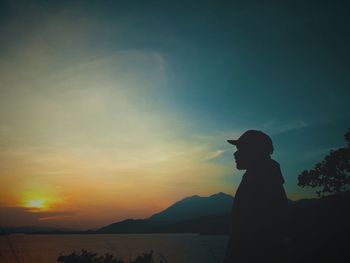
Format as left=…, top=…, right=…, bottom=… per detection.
left=287, top=130, right=350, bottom=263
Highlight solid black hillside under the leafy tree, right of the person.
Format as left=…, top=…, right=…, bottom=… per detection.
left=286, top=192, right=350, bottom=263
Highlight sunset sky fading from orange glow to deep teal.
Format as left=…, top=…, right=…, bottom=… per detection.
left=0, top=0, right=350, bottom=229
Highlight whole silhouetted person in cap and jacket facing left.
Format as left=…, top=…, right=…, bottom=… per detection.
left=224, top=130, right=288, bottom=263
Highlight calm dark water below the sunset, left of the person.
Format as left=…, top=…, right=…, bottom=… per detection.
left=0, top=234, right=227, bottom=263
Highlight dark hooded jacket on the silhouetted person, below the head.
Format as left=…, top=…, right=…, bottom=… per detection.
left=225, top=159, right=288, bottom=263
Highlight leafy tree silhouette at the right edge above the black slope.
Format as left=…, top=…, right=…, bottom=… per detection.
left=298, top=129, right=350, bottom=196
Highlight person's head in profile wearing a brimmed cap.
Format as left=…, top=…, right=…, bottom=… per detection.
left=227, top=130, right=274, bottom=170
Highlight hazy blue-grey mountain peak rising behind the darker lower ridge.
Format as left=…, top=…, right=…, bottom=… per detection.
left=148, top=192, right=233, bottom=222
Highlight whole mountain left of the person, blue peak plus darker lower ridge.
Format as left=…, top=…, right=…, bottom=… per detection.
left=98, top=192, right=234, bottom=233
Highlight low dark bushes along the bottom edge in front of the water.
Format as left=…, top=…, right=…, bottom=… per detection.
left=57, top=249, right=167, bottom=263
